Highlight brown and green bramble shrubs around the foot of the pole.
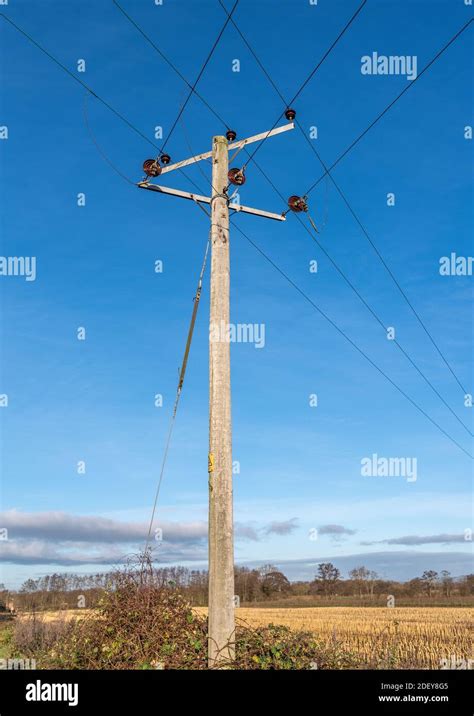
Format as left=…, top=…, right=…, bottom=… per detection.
left=18, top=569, right=356, bottom=669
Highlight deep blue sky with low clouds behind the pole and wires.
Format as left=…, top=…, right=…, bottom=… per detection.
left=0, top=0, right=473, bottom=587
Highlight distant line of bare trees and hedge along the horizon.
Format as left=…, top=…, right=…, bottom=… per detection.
left=0, top=562, right=474, bottom=611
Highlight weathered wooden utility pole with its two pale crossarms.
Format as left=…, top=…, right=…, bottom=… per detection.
left=138, top=122, right=295, bottom=667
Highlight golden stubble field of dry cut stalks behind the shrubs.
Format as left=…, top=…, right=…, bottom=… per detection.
left=197, top=607, right=474, bottom=669
